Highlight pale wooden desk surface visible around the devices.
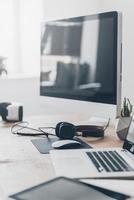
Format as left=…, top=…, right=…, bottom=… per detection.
left=0, top=115, right=132, bottom=200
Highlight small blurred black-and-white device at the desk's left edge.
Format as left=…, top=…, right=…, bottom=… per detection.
left=0, top=102, right=23, bottom=122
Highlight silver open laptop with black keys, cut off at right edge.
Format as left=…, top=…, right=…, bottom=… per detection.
left=50, top=122, right=134, bottom=179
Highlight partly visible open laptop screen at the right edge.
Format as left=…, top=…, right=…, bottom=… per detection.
left=123, top=120, right=134, bottom=154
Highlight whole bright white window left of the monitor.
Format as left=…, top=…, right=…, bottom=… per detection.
left=0, top=0, right=43, bottom=77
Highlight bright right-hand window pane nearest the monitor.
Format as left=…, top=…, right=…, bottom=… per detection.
left=18, top=0, right=43, bottom=76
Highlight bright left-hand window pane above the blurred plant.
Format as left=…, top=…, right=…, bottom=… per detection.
left=0, top=0, right=16, bottom=73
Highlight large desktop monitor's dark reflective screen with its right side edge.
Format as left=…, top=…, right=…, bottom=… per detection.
left=40, top=11, right=122, bottom=116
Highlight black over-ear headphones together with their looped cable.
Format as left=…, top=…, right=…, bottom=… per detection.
left=11, top=119, right=110, bottom=139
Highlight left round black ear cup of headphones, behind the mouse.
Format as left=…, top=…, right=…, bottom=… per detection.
left=56, top=122, right=76, bottom=139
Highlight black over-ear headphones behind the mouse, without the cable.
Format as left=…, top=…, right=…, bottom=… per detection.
left=55, top=122, right=108, bottom=139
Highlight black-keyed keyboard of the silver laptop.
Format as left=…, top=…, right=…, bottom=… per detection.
left=86, top=151, right=134, bottom=172
